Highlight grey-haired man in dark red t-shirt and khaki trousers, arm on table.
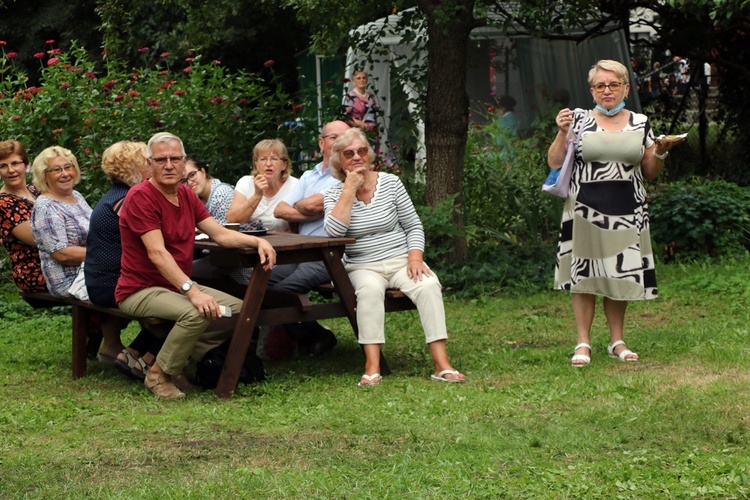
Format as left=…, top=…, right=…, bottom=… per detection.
left=115, top=132, right=276, bottom=399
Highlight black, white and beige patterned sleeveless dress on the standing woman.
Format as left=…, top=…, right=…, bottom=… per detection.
left=555, top=108, right=657, bottom=300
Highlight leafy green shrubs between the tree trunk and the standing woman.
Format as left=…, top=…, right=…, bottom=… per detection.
left=412, top=115, right=562, bottom=298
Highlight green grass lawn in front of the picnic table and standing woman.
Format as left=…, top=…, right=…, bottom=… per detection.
left=0, top=260, right=750, bottom=498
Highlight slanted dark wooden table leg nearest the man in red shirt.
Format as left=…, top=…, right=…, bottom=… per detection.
left=214, top=262, right=271, bottom=398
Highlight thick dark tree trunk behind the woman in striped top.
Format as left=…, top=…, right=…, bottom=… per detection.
left=417, top=0, right=474, bottom=262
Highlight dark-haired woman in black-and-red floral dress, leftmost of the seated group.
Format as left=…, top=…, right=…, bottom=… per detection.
left=0, top=140, right=47, bottom=292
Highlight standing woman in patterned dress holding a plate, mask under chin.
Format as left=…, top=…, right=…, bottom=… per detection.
left=547, top=60, right=679, bottom=367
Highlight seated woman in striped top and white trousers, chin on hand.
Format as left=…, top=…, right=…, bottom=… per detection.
left=324, top=128, right=465, bottom=387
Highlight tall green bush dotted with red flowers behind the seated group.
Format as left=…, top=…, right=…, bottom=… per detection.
left=0, top=40, right=308, bottom=202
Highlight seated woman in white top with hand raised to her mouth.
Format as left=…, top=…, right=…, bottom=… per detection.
left=227, top=139, right=298, bottom=233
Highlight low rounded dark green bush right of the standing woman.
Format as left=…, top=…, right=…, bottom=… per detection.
left=649, top=178, right=750, bottom=260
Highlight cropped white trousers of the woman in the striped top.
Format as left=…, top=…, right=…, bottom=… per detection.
left=346, top=256, right=448, bottom=344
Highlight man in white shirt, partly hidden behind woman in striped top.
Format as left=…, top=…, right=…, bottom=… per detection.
left=268, top=121, right=349, bottom=356
